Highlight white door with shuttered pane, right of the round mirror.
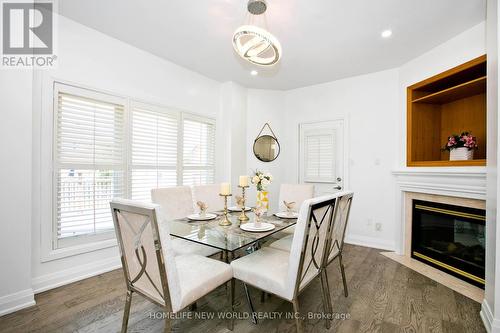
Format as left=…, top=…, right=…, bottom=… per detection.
left=299, top=119, right=345, bottom=196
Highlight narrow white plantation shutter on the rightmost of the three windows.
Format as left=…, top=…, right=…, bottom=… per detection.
left=182, top=116, right=215, bottom=185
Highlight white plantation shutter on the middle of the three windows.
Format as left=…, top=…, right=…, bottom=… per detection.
left=130, top=103, right=179, bottom=201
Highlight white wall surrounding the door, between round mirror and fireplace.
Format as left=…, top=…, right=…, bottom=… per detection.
left=280, top=70, right=400, bottom=249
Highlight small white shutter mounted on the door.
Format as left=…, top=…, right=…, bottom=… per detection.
left=304, top=130, right=336, bottom=182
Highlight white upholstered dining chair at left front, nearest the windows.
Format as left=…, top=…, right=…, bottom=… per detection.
left=110, top=199, right=234, bottom=332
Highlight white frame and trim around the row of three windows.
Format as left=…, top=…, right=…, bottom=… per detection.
left=38, top=74, right=217, bottom=262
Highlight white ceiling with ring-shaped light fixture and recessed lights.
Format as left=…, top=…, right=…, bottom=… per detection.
left=59, top=0, right=486, bottom=90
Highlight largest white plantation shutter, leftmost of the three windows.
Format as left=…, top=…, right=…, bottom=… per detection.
left=54, top=85, right=125, bottom=239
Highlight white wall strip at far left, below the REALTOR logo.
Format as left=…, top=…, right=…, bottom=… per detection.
left=0, top=69, right=34, bottom=315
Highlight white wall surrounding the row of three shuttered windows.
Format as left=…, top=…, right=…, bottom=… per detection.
left=29, top=17, right=225, bottom=291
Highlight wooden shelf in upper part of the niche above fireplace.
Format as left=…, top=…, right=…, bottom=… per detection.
left=412, top=76, right=486, bottom=104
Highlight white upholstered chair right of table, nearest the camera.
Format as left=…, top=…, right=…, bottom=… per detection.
left=231, top=195, right=336, bottom=332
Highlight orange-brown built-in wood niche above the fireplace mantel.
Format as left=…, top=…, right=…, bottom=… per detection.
left=407, top=55, right=486, bottom=166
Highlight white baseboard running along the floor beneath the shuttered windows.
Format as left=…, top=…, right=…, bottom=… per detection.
left=32, top=256, right=121, bottom=293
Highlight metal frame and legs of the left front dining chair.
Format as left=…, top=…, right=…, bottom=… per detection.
left=110, top=202, right=235, bottom=333
